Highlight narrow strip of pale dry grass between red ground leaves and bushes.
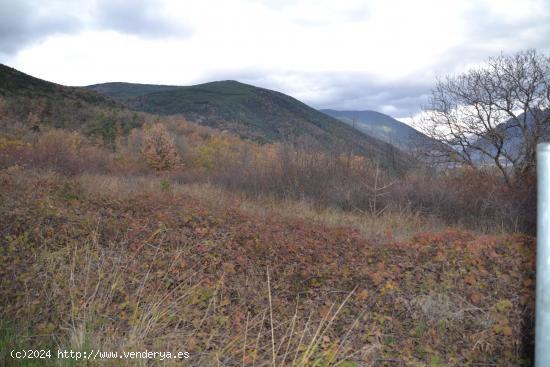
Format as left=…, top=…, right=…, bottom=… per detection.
left=79, top=174, right=458, bottom=242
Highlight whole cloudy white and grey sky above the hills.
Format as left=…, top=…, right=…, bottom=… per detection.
left=0, top=0, right=550, bottom=120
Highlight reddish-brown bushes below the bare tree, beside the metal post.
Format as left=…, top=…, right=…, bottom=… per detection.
left=391, top=169, right=536, bottom=233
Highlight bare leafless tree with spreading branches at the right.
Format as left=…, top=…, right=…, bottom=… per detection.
left=421, top=50, right=550, bottom=185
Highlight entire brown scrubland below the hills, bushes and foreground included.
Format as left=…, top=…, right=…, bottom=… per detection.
left=0, top=118, right=535, bottom=367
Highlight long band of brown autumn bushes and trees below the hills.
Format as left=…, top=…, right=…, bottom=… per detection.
left=0, top=118, right=536, bottom=233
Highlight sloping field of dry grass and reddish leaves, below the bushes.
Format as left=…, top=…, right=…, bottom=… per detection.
left=0, top=166, right=535, bottom=367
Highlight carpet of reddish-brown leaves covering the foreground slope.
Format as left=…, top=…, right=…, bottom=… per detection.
left=0, top=170, right=534, bottom=366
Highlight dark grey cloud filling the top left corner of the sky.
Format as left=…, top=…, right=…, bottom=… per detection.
left=0, top=0, right=81, bottom=55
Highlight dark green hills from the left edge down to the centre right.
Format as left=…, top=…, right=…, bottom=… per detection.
left=0, top=65, right=409, bottom=171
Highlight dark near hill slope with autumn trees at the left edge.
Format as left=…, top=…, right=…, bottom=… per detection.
left=0, top=64, right=149, bottom=144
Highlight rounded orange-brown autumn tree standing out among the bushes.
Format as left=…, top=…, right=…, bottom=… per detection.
left=142, top=123, right=178, bottom=171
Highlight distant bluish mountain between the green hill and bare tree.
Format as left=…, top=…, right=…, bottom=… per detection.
left=321, top=109, right=430, bottom=151
